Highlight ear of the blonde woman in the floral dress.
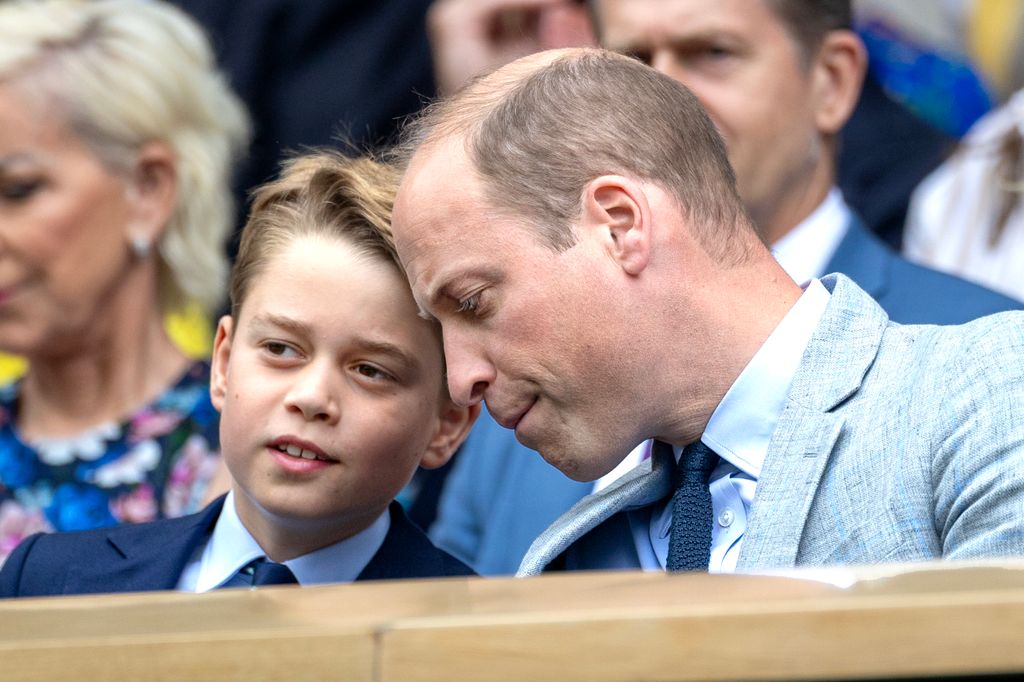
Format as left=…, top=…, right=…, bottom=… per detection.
left=125, top=141, right=178, bottom=251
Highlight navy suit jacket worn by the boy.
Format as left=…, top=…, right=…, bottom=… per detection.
left=0, top=497, right=473, bottom=597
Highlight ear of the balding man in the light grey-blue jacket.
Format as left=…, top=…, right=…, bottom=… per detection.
left=581, top=175, right=651, bottom=275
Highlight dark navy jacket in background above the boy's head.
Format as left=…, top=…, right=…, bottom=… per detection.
left=171, top=0, right=434, bottom=255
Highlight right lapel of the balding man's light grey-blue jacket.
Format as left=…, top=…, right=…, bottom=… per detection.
left=736, top=275, right=889, bottom=570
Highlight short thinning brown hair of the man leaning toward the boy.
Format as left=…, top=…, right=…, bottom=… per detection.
left=402, top=49, right=746, bottom=257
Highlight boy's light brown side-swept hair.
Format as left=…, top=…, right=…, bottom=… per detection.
left=230, top=150, right=402, bottom=318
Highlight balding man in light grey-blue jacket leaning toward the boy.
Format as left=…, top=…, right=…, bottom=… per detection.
left=393, top=50, right=1024, bottom=574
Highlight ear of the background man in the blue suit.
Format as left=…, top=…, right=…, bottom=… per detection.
left=811, top=29, right=867, bottom=135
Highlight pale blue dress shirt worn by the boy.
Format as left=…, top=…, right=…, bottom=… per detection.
left=177, top=492, right=391, bottom=592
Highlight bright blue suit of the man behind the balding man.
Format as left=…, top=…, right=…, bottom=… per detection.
left=430, top=212, right=1024, bottom=576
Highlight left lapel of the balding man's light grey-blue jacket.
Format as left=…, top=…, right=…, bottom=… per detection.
left=516, top=442, right=675, bottom=576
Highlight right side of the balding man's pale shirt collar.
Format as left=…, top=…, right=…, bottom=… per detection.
left=696, top=280, right=831, bottom=479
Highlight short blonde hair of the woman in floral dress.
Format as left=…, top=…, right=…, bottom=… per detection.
left=0, top=0, right=250, bottom=312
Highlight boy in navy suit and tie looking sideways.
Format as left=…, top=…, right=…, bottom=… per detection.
left=0, top=153, right=478, bottom=597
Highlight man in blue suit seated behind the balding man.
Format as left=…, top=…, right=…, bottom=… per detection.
left=421, top=0, right=1019, bottom=573
